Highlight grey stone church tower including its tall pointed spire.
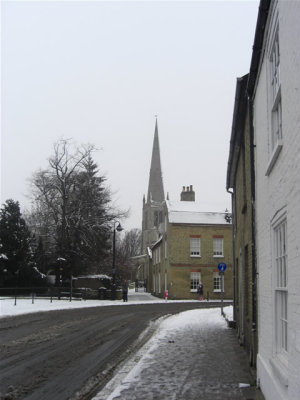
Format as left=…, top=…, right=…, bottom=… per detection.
left=142, top=119, right=165, bottom=254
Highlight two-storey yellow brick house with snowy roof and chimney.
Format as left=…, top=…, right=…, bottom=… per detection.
left=149, top=191, right=232, bottom=299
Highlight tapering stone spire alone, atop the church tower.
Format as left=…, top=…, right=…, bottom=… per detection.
left=147, top=118, right=165, bottom=202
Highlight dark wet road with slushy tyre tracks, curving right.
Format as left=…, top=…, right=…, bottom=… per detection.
left=0, top=296, right=221, bottom=400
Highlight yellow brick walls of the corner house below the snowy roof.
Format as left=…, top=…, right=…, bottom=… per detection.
left=152, top=224, right=232, bottom=299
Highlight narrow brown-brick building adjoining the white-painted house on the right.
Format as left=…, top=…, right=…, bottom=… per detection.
left=226, top=74, right=257, bottom=366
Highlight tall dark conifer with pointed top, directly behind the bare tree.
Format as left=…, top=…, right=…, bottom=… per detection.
left=69, top=155, right=115, bottom=273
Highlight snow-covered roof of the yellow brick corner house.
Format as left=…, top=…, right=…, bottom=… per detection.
left=166, top=200, right=229, bottom=225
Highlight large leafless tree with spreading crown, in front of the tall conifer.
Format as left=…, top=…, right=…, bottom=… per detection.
left=31, top=140, right=122, bottom=273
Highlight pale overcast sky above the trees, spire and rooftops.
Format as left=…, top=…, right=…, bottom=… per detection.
left=1, top=0, right=258, bottom=229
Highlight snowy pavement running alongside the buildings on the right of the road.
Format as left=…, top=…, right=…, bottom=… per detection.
left=93, top=293, right=264, bottom=400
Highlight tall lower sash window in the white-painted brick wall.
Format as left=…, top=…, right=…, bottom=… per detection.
left=272, top=215, right=288, bottom=356
